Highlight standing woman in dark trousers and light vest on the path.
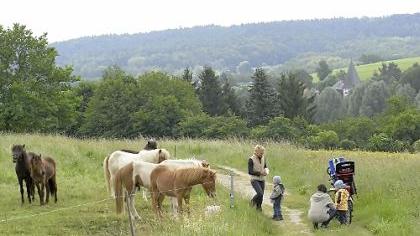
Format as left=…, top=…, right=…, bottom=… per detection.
left=248, top=145, right=268, bottom=211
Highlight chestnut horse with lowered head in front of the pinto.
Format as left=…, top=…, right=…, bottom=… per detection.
left=150, top=166, right=216, bottom=217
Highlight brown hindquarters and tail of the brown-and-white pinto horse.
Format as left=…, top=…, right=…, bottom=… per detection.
left=114, top=164, right=134, bottom=214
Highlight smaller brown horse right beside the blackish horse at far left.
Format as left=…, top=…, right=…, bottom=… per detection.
left=31, top=154, right=57, bottom=205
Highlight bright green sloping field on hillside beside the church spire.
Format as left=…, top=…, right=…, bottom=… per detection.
left=311, top=57, right=420, bottom=82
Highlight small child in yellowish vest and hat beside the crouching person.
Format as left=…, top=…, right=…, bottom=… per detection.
left=334, top=180, right=350, bottom=224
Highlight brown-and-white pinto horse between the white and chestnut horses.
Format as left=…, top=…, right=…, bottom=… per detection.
left=115, top=159, right=209, bottom=219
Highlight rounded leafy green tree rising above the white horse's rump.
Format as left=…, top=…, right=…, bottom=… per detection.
left=80, top=67, right=142, bottom=138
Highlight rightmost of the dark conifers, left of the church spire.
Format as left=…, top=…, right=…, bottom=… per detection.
left=277, top=74, right=315, bottom=121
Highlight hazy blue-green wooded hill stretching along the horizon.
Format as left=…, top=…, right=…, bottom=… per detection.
left=51, top=13, right=420, bottom=78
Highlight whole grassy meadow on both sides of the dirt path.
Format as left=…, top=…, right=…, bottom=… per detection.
left=0, top=134, right=420, bottom=235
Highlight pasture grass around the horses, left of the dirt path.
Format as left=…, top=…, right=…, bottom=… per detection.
left=0, top=134, right=281, bottom=235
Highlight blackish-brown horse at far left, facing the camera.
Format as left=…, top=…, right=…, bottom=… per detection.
left=12, top=144, right=35, bottom=204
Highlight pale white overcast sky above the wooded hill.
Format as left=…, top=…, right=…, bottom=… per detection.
left=0, top=0, right=420, bottom=42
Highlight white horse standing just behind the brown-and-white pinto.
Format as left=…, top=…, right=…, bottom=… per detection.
left=104, top=149, right=170, bottom=197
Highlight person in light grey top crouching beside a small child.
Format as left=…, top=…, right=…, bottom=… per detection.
left=308, top=184, right=336, bottom=229
